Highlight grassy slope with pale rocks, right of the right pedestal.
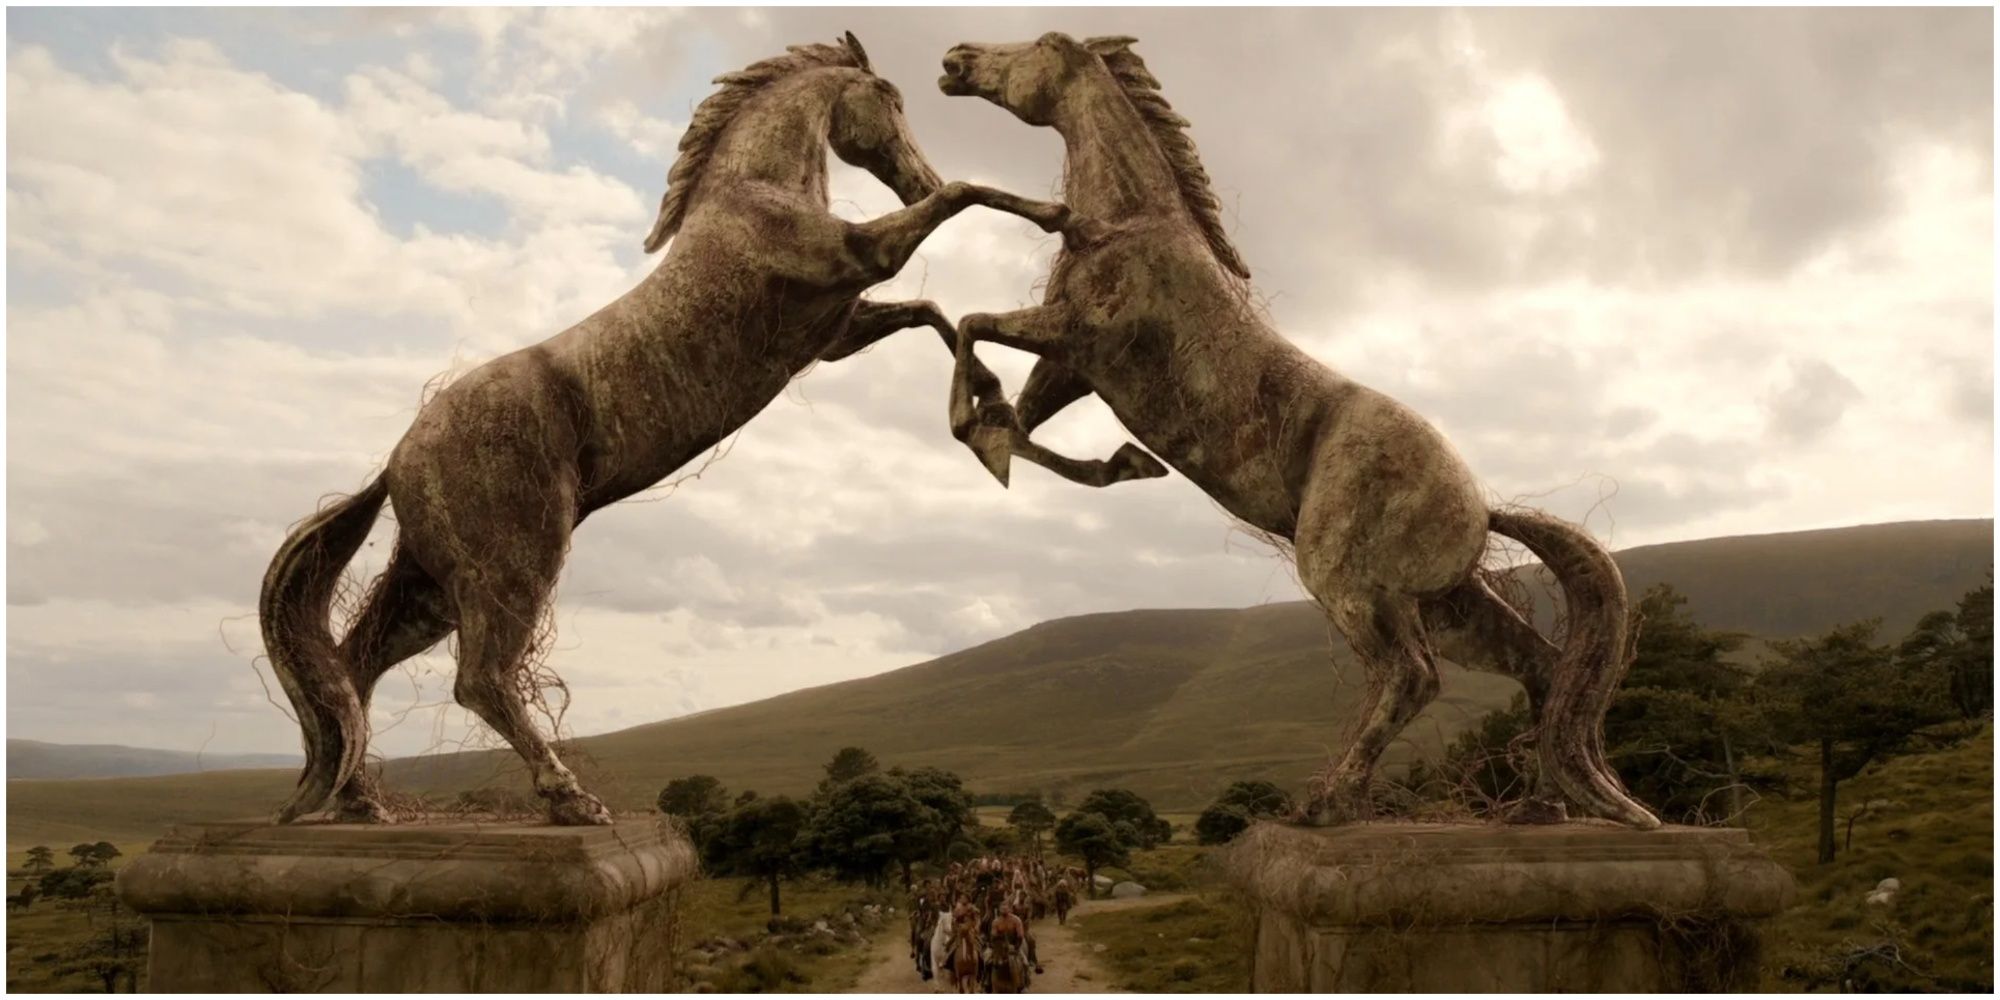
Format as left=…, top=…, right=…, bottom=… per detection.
left=1750, top=724, right=1994, bottom=992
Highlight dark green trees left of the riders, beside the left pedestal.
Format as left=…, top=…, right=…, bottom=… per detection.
left=660, top=746, right=976, bottom=916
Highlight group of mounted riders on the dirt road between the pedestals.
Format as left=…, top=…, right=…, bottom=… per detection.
left=910, top=858, right=1084, bottom=994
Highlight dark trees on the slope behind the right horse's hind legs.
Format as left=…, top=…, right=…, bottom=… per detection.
left=1416, top=582, right=1994, bottom=864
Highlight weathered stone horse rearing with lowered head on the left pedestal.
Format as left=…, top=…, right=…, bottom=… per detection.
left=270, top=34, right=1164, bottom=824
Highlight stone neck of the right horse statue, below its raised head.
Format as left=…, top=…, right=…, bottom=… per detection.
left=1054, top=66, right=1184, bottom=222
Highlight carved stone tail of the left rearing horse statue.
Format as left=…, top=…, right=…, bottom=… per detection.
left=258, top=476, right=388, bottom=822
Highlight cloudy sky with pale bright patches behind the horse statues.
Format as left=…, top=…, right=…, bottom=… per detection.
left=6, top=10, right=1994, bottom=754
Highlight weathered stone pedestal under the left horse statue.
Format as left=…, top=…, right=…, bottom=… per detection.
left=118, top=818, right=696, bottom=992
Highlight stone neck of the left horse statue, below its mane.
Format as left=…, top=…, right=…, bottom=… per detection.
left=698, top=68, right=856, bottom=206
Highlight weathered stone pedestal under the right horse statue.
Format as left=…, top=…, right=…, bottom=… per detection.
left=1226, top=824, right=1796, bottom=992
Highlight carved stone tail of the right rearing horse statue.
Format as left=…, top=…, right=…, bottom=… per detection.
left=1490, top=510, right=1660, bottom=830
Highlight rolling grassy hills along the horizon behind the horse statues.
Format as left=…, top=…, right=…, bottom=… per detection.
left=8, top=520, right=1992, bottom=850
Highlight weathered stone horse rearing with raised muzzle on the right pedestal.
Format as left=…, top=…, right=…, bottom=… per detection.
left=940, top=32, right=1660, bottom=828
